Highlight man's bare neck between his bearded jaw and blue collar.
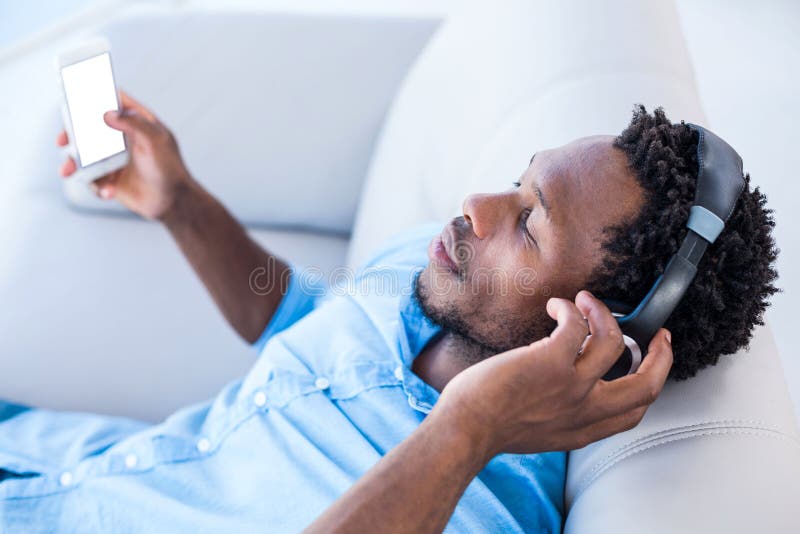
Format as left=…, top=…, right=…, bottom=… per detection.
left=411, top=332, right=491, bottom=393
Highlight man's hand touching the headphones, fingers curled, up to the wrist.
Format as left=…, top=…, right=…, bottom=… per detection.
left=432, top=291, right=672, bottom=459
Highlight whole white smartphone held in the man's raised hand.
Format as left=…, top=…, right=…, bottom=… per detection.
left=56, top=39, right=128, bottom=183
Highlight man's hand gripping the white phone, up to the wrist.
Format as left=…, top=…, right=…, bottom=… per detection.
left=56, top=92, right=192, bottom=219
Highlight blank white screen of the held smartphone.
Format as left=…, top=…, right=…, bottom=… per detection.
left=61, top=52, right=125, bottom=167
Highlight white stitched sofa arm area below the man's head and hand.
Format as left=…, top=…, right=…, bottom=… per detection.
left=566, top=326, right=800, bottom=534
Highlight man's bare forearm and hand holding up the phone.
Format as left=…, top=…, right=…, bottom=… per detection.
left=57, top=93, right=289, bottom=343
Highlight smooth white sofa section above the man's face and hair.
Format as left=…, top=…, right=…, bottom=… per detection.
left=349, top=0, right=705, bottom=265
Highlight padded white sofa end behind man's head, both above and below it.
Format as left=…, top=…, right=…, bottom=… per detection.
left=349, top=5, right=800, bottom=533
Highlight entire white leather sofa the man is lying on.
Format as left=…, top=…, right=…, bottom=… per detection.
left=0, top=0, right=800, bottom=533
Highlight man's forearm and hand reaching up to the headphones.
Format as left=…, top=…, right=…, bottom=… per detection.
left=306, top=292, right=672, bottom=533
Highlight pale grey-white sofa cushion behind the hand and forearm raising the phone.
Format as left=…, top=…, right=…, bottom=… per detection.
left=65, top=12, right=438, bottom=233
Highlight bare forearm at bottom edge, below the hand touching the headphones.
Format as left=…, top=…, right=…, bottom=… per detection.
left=306, top=411, right=490, bottom=533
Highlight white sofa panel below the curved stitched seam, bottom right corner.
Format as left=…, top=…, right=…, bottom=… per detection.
left=565, top=430, right=800, bottom=534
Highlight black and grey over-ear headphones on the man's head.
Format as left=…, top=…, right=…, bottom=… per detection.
left=603, top=123, right=744, bottom=380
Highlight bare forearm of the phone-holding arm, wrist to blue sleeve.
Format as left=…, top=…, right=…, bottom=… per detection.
left=162, top=179, right=289, bottom=343
